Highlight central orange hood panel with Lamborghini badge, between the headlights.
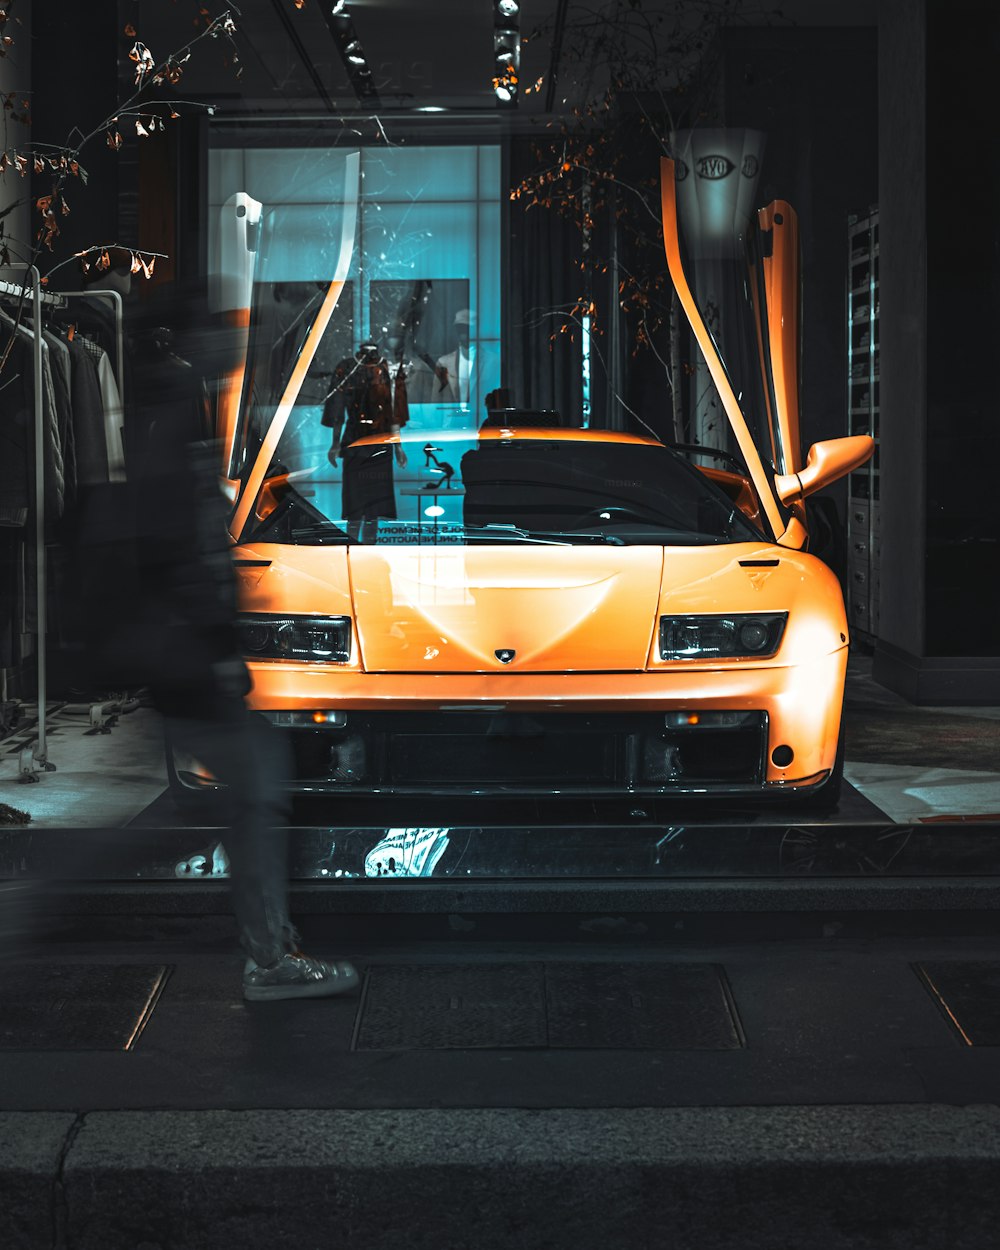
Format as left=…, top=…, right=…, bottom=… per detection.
left=348, top=544, right=663, bottom=673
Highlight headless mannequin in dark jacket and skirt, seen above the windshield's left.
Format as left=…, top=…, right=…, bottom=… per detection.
left=323, top=341, right=410, bottom=521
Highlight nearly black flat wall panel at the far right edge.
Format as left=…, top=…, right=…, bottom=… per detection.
left=926, top=0, right=1000, bottom=656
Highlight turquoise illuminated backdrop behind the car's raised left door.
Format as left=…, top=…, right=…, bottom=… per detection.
left=209, top=144, right=501, bottom=430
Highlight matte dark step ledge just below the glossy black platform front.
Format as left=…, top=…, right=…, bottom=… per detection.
left=29, top=878, right=1000, bottom=926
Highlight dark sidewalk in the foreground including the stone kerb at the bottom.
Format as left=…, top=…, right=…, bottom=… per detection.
left=0, top=913, right=1000, bottom=1250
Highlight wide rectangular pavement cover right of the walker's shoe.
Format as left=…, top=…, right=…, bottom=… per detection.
left=353, top=963, right=744, bottom=1050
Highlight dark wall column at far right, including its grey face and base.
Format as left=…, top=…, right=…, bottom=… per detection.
left=874, top=0, right=1000, bottom=704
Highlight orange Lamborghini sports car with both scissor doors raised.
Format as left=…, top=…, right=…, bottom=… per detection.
left=173, top=161, right=871, bottom=806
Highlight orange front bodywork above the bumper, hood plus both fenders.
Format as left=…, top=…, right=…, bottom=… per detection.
left=236, top=543, right=848, bottom=674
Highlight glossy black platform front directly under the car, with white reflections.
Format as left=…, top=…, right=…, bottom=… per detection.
left=0, top=820, right=1000, bottom=888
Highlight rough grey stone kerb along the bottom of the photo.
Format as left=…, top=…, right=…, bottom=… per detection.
left=0, top=1105, right=1000, bottom=1250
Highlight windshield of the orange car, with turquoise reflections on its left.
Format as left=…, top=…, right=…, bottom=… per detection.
left=244, top=426, right=761, bottom=546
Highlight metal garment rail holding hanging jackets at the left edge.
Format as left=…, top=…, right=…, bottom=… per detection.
left=0, top=265, right=125, bottom=781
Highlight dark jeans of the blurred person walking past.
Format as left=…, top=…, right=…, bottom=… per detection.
left=165, top=706, right=299, bottom=964
